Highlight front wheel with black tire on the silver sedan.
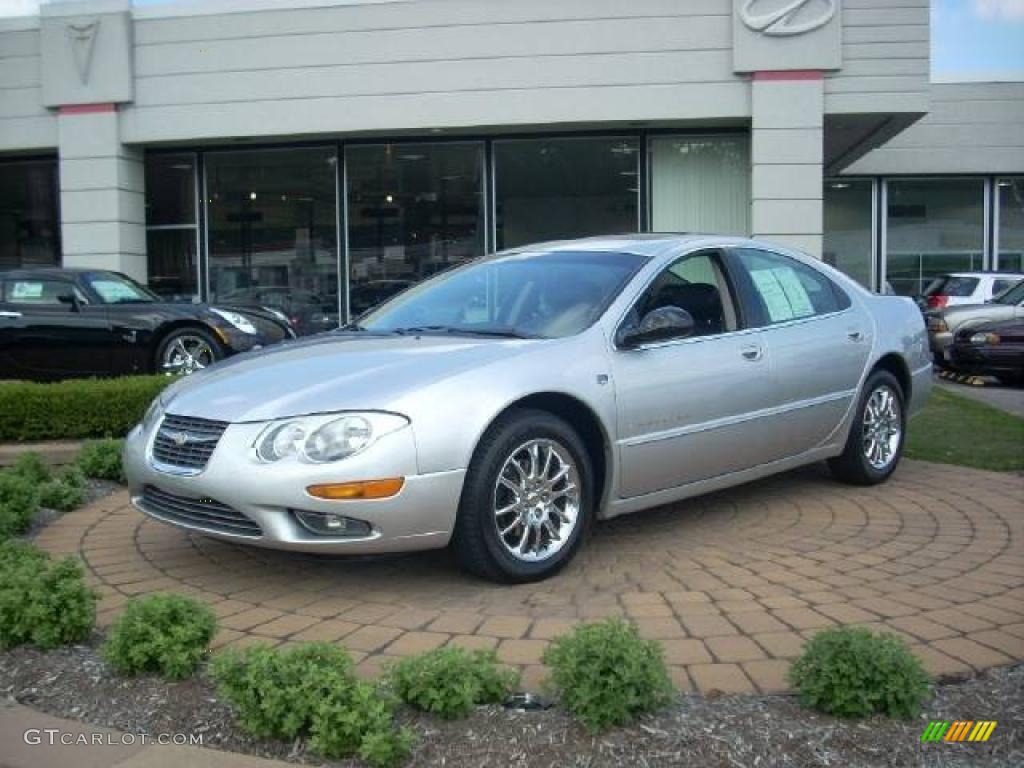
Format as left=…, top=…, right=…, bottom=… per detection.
left=453, top=409, right=594, bottom=584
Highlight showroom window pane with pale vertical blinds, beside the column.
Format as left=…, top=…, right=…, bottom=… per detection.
left=649, top=135, right=751, bottom=236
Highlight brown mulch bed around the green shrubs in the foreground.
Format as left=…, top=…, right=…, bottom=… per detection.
left=0, top=637, right=1024, bottom=768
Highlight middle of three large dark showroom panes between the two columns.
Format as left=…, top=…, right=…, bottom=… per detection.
left=345, top=142, right=484, bottom=317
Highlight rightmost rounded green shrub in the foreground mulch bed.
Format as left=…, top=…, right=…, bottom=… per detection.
left=790, top=627, right=929, bottom=718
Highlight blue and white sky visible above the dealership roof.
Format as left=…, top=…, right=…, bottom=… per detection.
left=0, top=0, right=1024, bottom=83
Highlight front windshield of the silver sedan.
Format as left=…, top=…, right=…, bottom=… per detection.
left=353, top=251, right=646, bottom=338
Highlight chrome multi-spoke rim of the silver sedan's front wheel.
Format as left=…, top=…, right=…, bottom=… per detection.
left=493, top=438, right=581, bottom=562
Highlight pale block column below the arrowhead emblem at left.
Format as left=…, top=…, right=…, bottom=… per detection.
left=57, top=103, right=146, bottom=283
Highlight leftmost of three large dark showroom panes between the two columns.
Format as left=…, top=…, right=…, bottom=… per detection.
left=206, top=147, right=338, bottom=334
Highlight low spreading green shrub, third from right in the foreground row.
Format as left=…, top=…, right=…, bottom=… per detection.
left=388, top=646, right=518, bottom=720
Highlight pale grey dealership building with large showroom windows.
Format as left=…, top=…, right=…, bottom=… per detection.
left=0, top=0, right=1024, bottom=318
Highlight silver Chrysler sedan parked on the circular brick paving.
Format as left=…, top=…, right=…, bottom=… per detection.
left=125, top=236, right=931, bottom=582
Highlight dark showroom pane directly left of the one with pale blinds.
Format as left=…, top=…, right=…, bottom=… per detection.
left=495, top=137, right=640, bottom=249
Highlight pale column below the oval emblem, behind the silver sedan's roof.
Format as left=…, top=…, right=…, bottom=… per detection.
left=751, top=70, right=824, bottom=258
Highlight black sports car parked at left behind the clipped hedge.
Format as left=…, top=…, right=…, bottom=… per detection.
left=0, top=267, right=295, bottom=381
